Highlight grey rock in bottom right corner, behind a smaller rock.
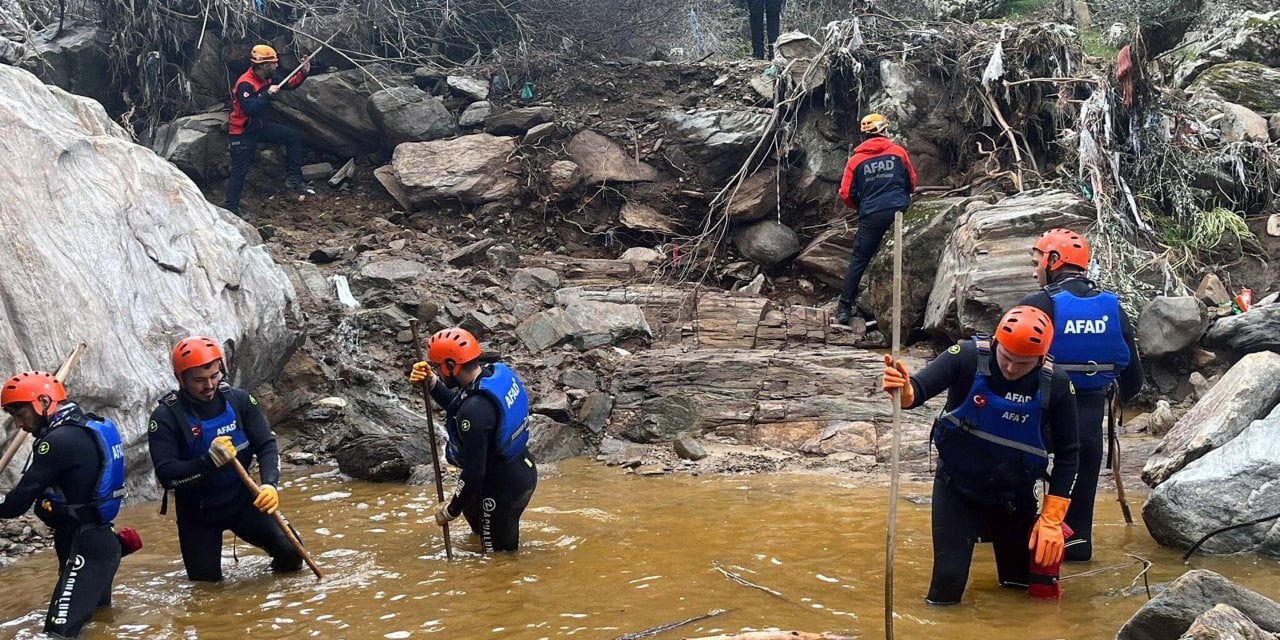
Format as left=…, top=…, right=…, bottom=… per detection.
left=1116, top=570, right=1280, bottom=640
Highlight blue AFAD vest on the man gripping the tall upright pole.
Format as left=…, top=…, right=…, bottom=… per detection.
left=933, top=335, right=1053, bottom=503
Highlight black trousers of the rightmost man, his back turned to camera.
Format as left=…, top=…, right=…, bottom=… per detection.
left=1062, top=392, right=1107, bottom=562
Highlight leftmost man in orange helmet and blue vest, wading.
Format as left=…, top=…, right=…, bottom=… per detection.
left=0, top=371, right=124, bottom=637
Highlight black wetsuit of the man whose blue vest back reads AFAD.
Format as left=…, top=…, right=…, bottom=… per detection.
left=1019, top=274, right=1143, bottom=562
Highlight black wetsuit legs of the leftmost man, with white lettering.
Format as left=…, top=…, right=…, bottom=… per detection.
left=45, top=524, right=120, bottom=637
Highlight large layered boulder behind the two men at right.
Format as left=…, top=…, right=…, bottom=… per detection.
left=924, top=189, right=1092, bottom=339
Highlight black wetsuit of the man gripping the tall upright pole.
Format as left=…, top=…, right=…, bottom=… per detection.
left=911, top=340, right=1080, bottom=604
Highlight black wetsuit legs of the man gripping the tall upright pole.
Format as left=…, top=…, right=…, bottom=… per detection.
left=925, top=471, right=1036, bottom=604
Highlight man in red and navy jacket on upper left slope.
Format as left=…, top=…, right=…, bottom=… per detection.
left=223, top=45, right=315, bottom=215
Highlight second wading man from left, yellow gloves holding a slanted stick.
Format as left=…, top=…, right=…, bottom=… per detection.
left=147, top=335, right=302, bottom=582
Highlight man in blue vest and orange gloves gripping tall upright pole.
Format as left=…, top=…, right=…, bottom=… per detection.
left=883, top=306, right=1079, bottom=604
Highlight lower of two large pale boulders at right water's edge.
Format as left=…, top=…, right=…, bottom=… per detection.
left=1142, top=411, right=1280, bottom=557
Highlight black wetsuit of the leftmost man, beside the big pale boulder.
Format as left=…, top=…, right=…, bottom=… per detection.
left=0, top=404, right=120, bottom=637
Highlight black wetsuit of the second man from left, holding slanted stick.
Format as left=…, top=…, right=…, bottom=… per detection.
left=147, top=384, right=302, bottom=581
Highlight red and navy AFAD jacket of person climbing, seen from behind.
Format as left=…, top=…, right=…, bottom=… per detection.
left=840, top=136, right=915, bottom=215
